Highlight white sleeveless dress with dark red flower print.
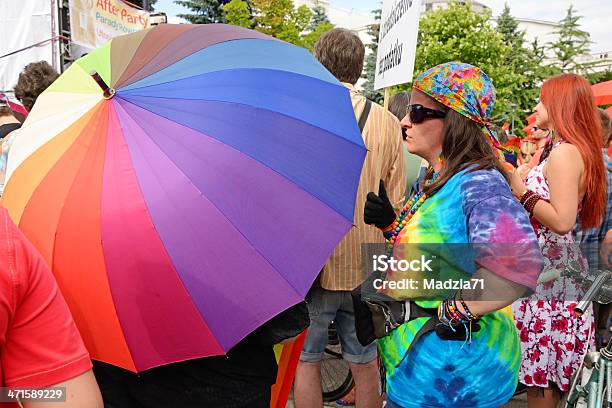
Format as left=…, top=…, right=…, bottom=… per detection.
left=512, top=144, right=595, bottom=392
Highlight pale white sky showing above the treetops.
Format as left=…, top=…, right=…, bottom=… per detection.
left=155, top=0, right=612, bottom=52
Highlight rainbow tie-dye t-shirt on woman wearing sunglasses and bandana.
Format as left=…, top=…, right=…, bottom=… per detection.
left=379, top=170, right=542, bottom=408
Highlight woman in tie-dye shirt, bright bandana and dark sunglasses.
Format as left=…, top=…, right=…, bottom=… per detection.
left=362, top=62, right=542, bottom=408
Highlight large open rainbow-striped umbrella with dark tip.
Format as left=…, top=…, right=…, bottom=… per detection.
left=2, top=25, right=366, bottom=371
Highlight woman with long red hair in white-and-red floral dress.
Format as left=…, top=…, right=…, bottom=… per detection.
left=511, top=74, right=607, bottom=407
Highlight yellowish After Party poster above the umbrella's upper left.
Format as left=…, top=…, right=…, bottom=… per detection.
left=69, top=0, right=149, bottom=48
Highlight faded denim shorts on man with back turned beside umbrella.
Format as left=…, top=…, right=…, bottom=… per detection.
left=300, top=288, right=377, bottom=364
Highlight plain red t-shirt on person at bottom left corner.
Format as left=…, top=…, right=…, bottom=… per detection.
left=0, top=207, right=91, bottom=394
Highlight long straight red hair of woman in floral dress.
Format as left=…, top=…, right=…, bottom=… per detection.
left=541, top=74, right=608, bottom=229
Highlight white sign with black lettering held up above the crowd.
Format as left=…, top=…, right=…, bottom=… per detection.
left=374, top=0, right=421, bottom=89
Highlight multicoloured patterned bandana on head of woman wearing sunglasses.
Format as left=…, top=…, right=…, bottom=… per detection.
left=413, top=62, right=499, bottom=148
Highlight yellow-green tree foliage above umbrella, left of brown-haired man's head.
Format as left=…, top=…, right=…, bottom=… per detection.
left=252, top=0, right=313, bottom=46
